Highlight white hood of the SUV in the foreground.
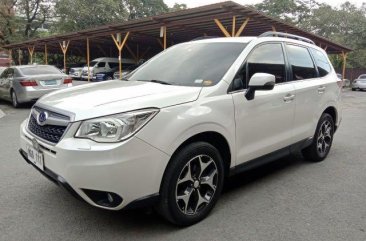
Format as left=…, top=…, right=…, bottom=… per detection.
left=36, top=80, right=202, bottom=121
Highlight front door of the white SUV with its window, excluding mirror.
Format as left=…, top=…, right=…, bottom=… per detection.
left=232, top=43, right=295, bottom=164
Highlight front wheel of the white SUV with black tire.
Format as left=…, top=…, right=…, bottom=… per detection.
left=157, top=142, right=225, bottom=226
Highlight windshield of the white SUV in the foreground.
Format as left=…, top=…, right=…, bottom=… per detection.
left=128, top=42, right=246, bottom=86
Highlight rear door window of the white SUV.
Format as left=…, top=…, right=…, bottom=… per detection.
left=286, top=44, right=317, bottom=80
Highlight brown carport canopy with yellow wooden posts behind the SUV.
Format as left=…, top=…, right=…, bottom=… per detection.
left=4, top=1, right=351, bottom=79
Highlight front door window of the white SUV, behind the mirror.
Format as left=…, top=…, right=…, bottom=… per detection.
left=232, top=43, right=286, bottom=90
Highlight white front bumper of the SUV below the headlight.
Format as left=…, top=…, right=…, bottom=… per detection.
left=20, top=121, right=170, bottom=210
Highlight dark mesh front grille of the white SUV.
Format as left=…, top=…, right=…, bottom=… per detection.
left=28, top=115, right=66, bottom=144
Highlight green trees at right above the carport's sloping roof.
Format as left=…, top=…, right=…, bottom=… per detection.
left=255, top=0, right=366, bottom=68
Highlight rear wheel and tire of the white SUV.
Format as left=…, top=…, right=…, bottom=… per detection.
left=302, top=113, right=334, bottom=162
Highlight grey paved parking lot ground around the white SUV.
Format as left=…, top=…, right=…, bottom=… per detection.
left=0, top=90, right=366, bottom=241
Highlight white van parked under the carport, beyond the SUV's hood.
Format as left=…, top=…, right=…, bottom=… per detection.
left=81, top=57, right=135, bottom=80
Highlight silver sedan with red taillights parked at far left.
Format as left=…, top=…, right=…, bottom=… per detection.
left=0, top=65, right=72, bottom=108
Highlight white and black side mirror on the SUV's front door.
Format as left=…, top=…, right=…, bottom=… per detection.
left=245, top=73, right=276, bottom=100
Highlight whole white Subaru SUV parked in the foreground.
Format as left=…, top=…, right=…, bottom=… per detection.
left=20, top=33, right=341, bottom=225
